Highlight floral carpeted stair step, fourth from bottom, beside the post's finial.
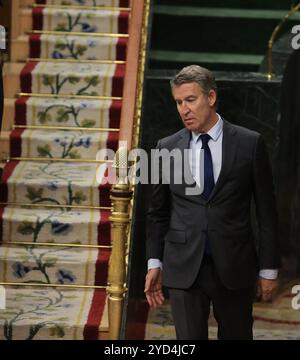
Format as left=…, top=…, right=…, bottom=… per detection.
left=0, top=161, right=113, bottom=207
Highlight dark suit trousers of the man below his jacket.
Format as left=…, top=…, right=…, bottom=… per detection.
left=168, top=255, right=255, bottom=340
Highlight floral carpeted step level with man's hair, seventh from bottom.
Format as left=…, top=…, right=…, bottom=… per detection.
left=21, top=62, right=125, bottom=97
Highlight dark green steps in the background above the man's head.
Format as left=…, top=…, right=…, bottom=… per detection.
left=150, top=0, right=300, bottom=72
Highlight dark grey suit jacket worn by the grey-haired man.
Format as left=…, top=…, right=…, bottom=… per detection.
left=147, top=121, right=280, bottom=289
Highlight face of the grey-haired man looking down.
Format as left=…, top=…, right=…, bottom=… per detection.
left=172, top=82, right=216, bottom=132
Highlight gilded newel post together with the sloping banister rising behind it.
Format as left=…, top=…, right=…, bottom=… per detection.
left=107, top=0, right=150, bottom=340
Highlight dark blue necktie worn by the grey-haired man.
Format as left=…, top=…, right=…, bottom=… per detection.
left=200, top=134, right=215, bottom=255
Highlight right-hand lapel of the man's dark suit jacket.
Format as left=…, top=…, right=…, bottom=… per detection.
left=208, top=119, right=238, bottom=201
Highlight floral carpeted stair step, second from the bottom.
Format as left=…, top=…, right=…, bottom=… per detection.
left=0, top=243, right=110, bottom=286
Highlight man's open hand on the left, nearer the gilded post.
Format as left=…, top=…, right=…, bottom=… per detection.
left=144, top=268, right=165, bottom=307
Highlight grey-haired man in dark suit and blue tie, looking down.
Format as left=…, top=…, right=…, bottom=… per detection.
left=145, top=65, right=280, bottom=340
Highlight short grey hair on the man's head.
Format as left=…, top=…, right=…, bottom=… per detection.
left=170, top=65, right=217, bottom=95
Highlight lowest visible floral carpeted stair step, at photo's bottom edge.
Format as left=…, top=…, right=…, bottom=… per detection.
left=0, top=287, right=108, bottom=340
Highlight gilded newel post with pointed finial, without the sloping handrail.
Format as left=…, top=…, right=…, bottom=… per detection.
left=107, top=147, right=132, bottom=340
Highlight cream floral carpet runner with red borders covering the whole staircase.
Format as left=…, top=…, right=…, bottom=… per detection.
left=0, top=0, right=129, bottom=340
